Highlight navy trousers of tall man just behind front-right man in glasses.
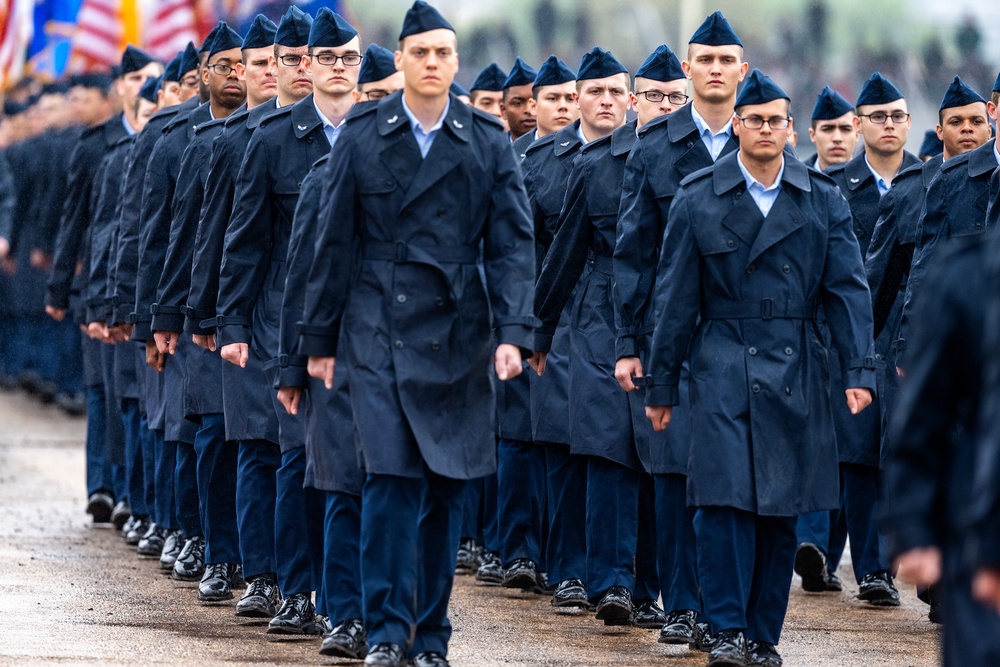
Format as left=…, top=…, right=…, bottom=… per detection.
left=653, top=474, right=701, bottom=612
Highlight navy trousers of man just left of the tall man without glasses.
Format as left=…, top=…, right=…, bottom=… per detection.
left=584, top=456, right=639, bottom=603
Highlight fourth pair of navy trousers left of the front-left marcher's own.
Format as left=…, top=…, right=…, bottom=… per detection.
left=194, top=412, right=240, bottom=563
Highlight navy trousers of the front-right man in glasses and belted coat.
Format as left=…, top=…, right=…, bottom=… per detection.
left=694, top=507, right=796, bottom=644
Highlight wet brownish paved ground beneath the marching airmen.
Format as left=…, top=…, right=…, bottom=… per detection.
left=0, top=393, right=938, bottom=667
